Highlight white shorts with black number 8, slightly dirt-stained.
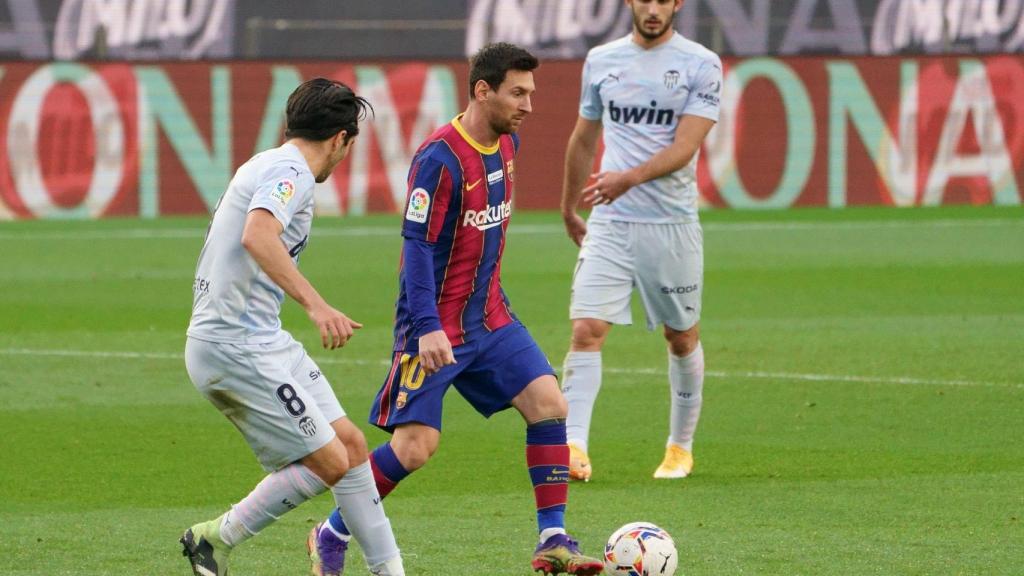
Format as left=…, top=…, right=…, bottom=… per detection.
left=185, top=332, right=345, bottom=471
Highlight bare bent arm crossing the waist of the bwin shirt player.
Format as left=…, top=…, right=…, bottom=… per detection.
left=583, top=115, right=715, bottom=205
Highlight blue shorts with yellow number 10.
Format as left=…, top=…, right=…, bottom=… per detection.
left=370, top=322, right=555, bottom=431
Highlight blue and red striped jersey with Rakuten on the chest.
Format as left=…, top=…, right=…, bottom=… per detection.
left=394, top=116, right=519, bottom=351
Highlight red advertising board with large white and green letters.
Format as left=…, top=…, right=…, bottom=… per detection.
left=0, top=56, right=1024, bottom=219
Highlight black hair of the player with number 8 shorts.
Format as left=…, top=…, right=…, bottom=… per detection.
left=285, top=78, right=374, bottom=143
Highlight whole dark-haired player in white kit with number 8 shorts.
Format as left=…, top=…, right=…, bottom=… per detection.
left=181, top=78, right=403, bottom=576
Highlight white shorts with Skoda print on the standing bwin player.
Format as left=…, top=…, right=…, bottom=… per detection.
left=569, top=221, right=703, bottom=331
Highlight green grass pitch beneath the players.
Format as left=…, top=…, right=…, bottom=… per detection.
left=0, top=207, right=1024, bottom=576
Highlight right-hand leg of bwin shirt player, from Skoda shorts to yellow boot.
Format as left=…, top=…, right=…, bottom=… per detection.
left=636, top=222, right=705, bottom=479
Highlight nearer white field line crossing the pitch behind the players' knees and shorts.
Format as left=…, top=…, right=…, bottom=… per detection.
left=0, top=348, right=1024, bottom=389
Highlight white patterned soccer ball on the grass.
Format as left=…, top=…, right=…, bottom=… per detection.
left=604, top=522, right=679, bottom=576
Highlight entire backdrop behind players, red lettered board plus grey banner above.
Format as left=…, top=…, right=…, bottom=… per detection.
left=0, top=0, right=1024, bottom=219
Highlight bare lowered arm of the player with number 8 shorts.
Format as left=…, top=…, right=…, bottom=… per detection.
left=242, top=208, right=362, bottom=349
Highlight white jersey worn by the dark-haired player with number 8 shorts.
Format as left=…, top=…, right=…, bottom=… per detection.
left=188, top=143, right=315, bottom=344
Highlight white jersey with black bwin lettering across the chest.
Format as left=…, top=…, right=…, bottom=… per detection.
left=580, top=33, right=722, bottom=223
